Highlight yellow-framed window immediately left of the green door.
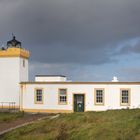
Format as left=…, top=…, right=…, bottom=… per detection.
left=59, top=89, right=67, bottom=104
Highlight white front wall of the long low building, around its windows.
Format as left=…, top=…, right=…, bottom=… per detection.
left=22, top=83, right=140, bottom=111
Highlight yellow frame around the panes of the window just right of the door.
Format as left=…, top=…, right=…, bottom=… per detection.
left=94, top=88, right=105, bottom=106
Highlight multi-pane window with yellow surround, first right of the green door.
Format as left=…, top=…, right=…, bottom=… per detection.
left=95, top=89, right=104, bottom=105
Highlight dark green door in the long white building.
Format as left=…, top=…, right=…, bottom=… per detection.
left=74, top=94, right=84, bottom=112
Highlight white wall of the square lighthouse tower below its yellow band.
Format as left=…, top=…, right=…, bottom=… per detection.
left=0, top=57, right=28, bottom=106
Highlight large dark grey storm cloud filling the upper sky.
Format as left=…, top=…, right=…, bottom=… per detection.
left=0, top=0, right=140, bottom=65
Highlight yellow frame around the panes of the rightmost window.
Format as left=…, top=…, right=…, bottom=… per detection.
left=120, top=88, right=131, bottom=106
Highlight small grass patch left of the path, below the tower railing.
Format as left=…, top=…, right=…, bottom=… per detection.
left=0, top=112, right=24, bottom=123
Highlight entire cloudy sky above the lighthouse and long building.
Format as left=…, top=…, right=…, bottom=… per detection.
left=0, top=0, right=140, bottom=81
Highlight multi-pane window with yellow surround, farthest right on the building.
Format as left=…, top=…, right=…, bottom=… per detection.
left=121, top=89, right=130, bottom=106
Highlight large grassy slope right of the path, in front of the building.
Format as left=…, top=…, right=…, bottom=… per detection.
left=1, top=109, right=140, bottom=140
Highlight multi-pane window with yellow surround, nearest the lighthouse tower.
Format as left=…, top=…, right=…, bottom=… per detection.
left=35, top=89, right=43, bottom=103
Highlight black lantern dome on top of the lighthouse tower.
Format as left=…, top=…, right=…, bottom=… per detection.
left=7, top=36, right=21, bottom=48
